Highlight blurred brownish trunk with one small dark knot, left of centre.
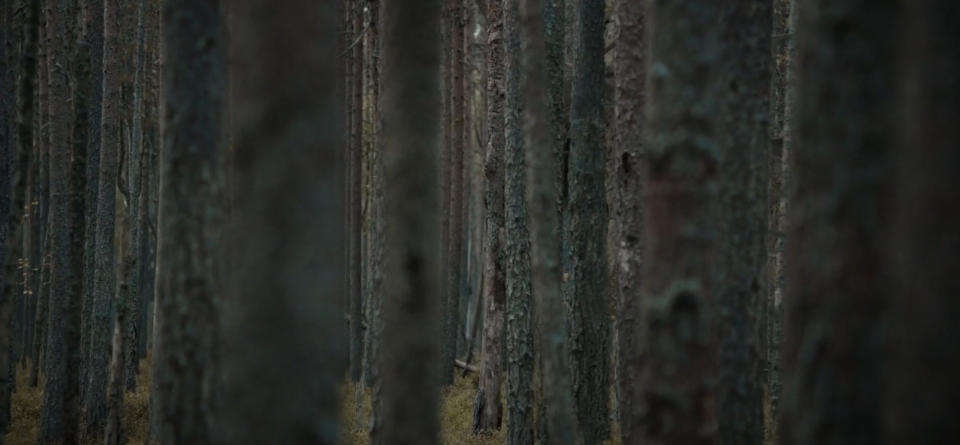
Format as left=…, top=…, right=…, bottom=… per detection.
left=372, top=0, right=442, bottom=445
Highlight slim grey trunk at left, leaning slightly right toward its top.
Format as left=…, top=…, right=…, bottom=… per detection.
left=85, top=0, right=125, bottom=437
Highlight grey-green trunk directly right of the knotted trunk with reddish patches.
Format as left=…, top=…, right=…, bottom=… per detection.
left=711, top=0, right=773, bottom=444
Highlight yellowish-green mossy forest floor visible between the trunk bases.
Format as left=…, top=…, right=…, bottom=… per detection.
left=3, top=361, right=618, bottom=445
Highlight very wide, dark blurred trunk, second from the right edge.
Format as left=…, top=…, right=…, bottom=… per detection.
left=781, top=0, right=906, bottom=445
